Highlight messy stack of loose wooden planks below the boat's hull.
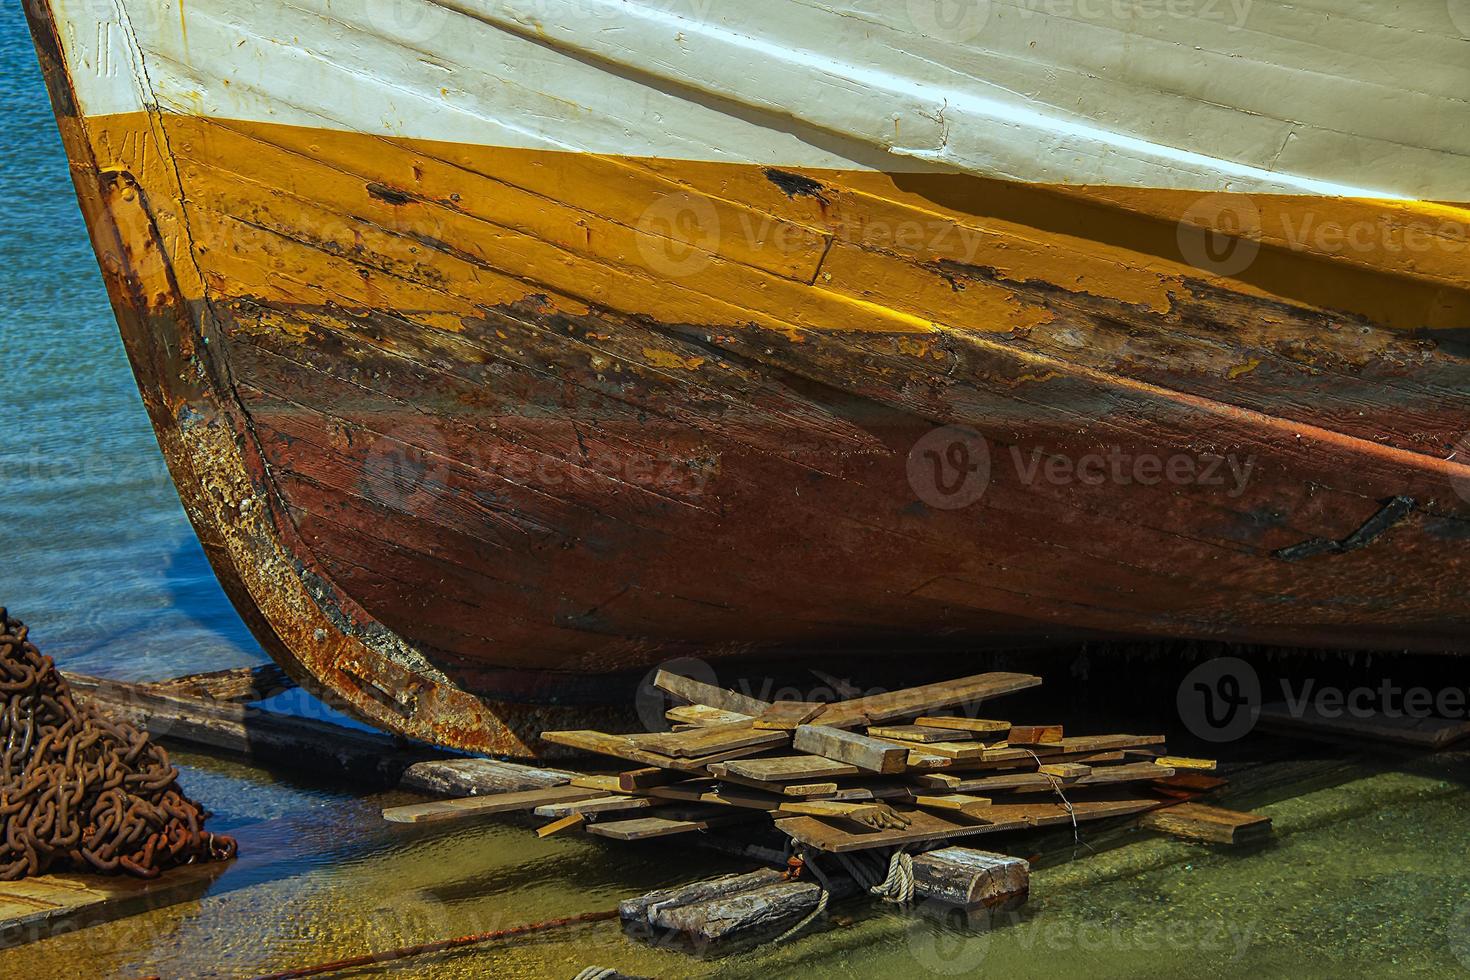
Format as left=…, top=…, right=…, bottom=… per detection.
left=387, top=671, right=1246, bottom=852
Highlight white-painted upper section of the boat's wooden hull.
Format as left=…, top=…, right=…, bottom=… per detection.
left=45, top=0, right=1470, bottom=201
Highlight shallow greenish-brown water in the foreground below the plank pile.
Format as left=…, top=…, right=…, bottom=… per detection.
left=0, top=755, right=1470, bottom=980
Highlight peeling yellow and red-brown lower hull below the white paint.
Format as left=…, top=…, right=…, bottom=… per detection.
left=22, top=6, right=1470, bottom=755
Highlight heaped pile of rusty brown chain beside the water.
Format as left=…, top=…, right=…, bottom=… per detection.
left=0, top=608, right=235, bottom=882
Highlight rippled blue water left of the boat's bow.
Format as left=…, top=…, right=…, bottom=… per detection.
left=0, top=3, right=265, bottom=680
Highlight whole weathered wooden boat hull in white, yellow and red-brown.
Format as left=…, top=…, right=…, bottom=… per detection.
left=31, top=0, right=1470, bottom=752
